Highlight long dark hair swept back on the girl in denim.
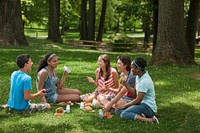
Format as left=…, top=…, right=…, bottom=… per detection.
left=36, top=52, right=56, bottom=73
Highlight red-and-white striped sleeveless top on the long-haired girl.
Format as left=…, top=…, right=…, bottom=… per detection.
left=96, top=67, right=116, bottom=96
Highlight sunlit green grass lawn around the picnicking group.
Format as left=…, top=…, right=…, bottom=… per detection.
left=0, top=34, right=200, bottom=133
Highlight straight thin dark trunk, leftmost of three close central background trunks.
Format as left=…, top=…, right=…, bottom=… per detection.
left=80, top=0, right=87, bottom=40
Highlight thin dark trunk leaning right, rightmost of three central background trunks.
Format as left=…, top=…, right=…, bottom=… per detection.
left=96, top=0, right=107, bottom=41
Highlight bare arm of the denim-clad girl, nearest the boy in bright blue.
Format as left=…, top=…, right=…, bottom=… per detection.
left=38, top=70, right=48, bottom=103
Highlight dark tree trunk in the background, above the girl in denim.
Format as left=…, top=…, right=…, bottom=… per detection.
left=47, top=0, right=62, bottom=43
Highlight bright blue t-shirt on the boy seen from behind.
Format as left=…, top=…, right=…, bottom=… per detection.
left=8, top=71, right=32, bottom=111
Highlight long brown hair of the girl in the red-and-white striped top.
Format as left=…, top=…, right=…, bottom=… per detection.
left=99, top=54, right=111, bottom=81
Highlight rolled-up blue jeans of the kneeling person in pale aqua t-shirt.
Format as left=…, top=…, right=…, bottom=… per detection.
left=115, top=103, right=155, bottom=120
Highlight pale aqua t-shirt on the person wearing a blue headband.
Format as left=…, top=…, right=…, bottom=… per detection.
left=136, top=72, right=157, bottom=112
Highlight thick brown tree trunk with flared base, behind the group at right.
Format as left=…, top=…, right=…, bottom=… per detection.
left=152, top=0, right=194, bottom=65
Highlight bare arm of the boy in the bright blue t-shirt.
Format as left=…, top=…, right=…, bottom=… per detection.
left=24, top=89, right=46, bottom=100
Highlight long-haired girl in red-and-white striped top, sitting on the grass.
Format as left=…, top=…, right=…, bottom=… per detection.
left=83, top=54, right=118, bottom=102
